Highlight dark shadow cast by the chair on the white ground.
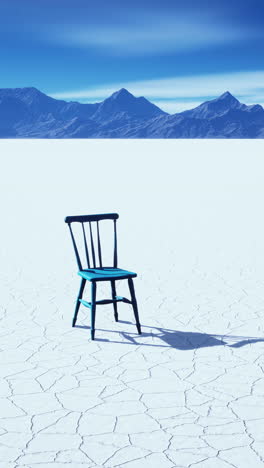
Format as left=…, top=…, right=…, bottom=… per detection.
left=75, top=320, right=264, bottom=351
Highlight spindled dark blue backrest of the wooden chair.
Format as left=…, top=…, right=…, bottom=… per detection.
left=65, top=213, right=119, bottom=270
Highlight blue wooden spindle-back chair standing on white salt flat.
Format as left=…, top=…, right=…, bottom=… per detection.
left=65, top=213, right=141, bottom=340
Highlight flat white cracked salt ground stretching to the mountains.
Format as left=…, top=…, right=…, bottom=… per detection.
left=0, top=140, right=264, bottom=468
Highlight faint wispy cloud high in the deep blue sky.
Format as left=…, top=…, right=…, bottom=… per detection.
left=46, top=11, right=256, bottom=56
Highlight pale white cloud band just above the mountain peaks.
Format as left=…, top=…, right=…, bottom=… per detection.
left=52, top=70, right=264, bottom=113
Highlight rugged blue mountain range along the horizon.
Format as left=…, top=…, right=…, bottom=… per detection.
left=0, top=88, right=264, bottom=138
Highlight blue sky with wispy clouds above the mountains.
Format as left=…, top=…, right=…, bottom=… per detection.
left=0, top=0, right=264, bottom=112
